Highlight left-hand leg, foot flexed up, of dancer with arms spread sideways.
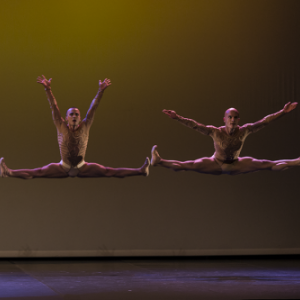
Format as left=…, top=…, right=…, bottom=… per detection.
left=151, top=146, right=222, bottom=175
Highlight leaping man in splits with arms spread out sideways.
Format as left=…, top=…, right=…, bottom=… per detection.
left=151, top=102, right=300, bottom=175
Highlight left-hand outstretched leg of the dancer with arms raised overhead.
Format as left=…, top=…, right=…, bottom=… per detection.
left=0, top=157, right=69, bottom=179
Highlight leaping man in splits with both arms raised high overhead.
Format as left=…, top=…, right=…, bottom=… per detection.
left=0, top=75, right=150, bottom=179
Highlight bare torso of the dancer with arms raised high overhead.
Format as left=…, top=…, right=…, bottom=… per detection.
left=56, top=122, right=89, bottom=166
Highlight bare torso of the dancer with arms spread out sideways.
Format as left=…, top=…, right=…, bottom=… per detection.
left=210, top=126, right=250, bottom=163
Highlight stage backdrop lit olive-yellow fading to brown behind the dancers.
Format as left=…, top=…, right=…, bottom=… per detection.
left=0, top=0, right=300, bottom=257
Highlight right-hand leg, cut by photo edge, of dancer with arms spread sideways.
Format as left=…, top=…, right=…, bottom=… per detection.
left=229, top=157, right=300, bottom=175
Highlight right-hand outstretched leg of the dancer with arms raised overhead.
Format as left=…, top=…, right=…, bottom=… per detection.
left=77, top=157, right=150, bottom=178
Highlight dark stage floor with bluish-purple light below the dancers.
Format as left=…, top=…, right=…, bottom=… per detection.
left=0, top=256, right=300, bottom=300
